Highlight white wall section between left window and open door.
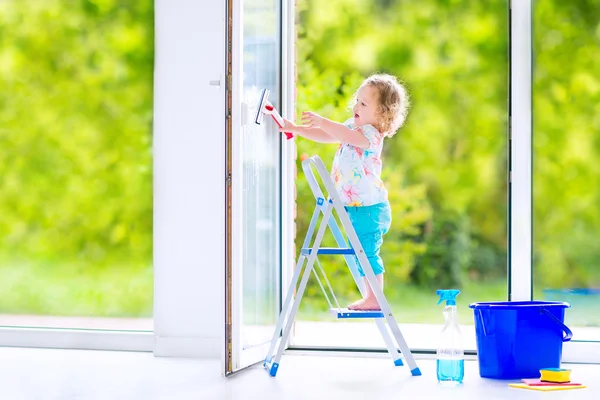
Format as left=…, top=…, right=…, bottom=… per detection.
left=154, top=0, right=226, bottom=357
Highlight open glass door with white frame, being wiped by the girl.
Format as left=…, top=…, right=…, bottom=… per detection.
left=223, top=0, right=293, bottom=376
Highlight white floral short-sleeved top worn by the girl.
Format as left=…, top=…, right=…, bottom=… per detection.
left=331, top=118, right=388, bottom=206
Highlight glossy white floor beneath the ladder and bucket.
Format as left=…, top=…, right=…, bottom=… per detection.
left=0, top=348, right=600, bottom=400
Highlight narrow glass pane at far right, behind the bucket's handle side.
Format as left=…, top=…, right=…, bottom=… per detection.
left=533, top=0, right=600, bottom=341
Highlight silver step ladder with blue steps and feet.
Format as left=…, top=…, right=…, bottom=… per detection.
left=263, top=156, right=421, bottom=376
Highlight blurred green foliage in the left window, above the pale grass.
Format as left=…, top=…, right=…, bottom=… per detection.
left=0, top=0, right=154, bottom=265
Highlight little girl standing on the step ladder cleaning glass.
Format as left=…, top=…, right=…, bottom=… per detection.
left=280, top=74, right=409, bottom=310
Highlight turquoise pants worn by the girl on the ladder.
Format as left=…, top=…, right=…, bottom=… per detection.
left=345, top=202, right=392, bottom=276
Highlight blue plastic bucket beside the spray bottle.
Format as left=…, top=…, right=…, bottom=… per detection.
left=469, top=301, right=573, bottom=379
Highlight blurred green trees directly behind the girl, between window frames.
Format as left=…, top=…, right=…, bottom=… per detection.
left=297, top=0, right=509, bottom=292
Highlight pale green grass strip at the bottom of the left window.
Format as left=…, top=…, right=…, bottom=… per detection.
left=0, top=257, right=154, bottom=317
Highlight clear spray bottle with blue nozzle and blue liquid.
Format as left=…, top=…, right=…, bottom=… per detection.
left=437, top=290, right=465, bottom=385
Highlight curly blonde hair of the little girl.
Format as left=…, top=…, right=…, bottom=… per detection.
left=354, top=74, right=410, bottom=137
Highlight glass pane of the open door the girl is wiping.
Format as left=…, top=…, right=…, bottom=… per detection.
left=240, top=0, right=281, bottom=348
